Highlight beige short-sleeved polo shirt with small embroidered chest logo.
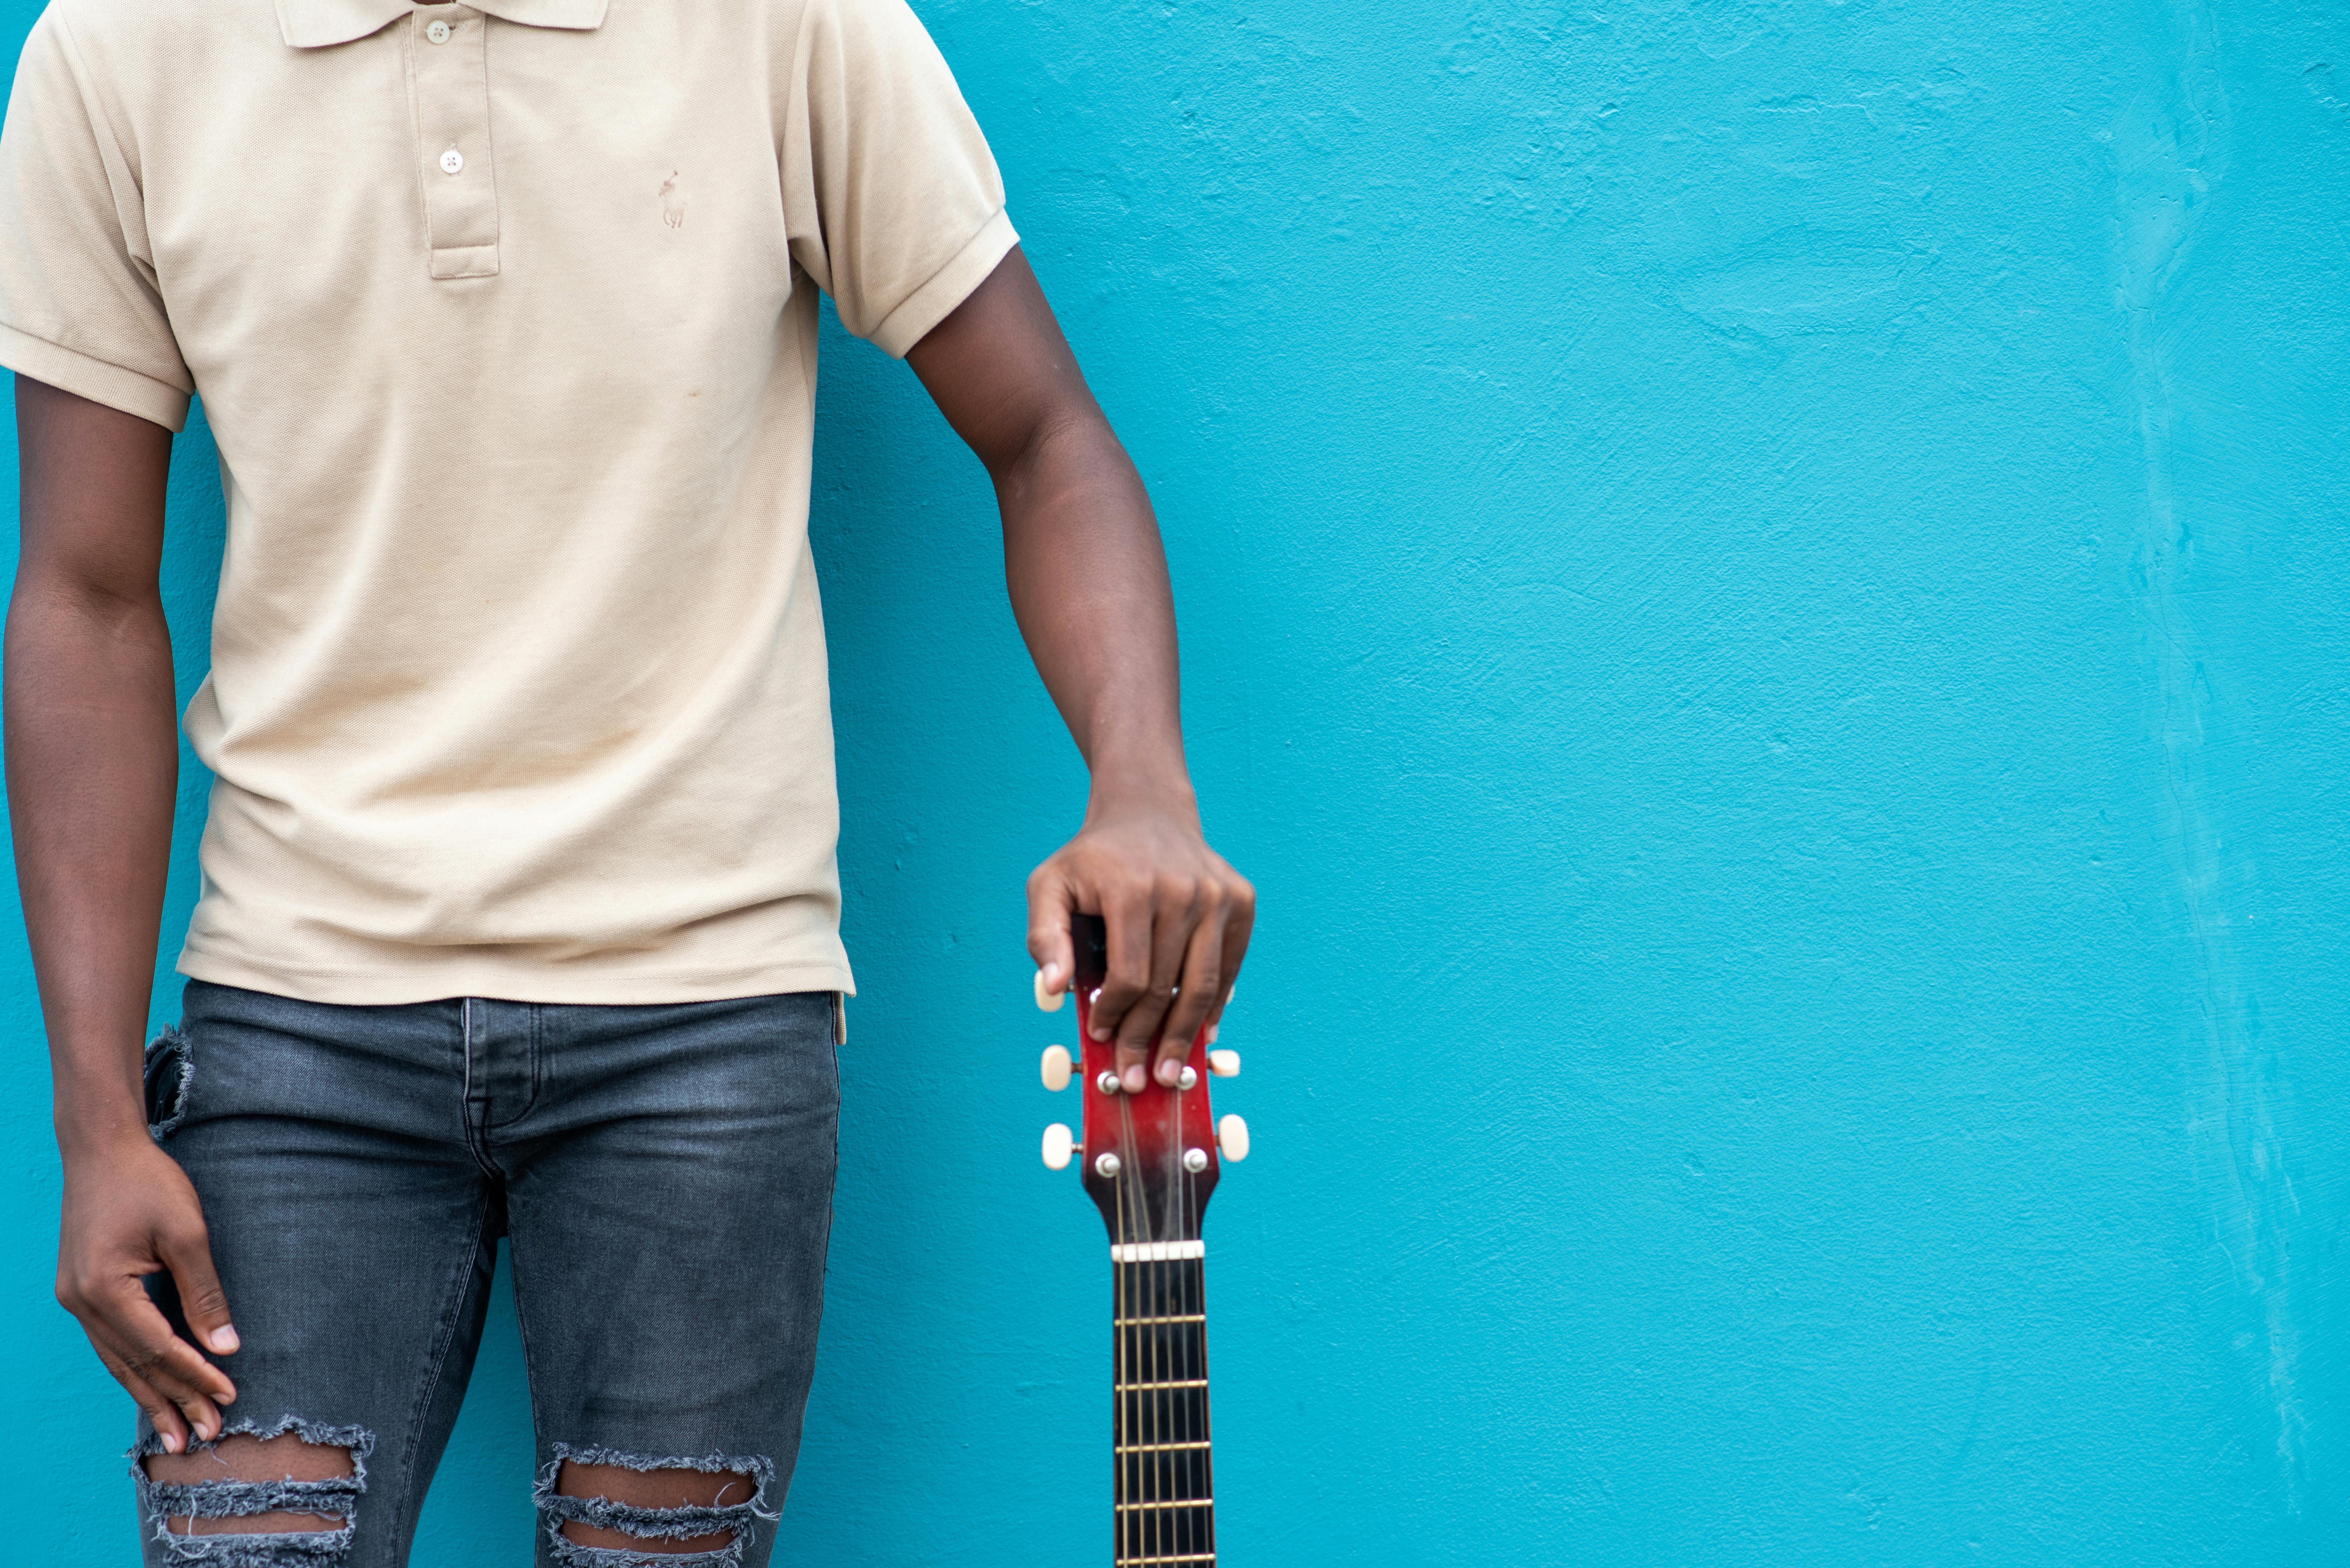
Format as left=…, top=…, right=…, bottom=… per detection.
left=0, top=0, right=1015, bottom=1001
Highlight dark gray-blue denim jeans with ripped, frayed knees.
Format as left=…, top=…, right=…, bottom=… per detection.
left=132, top=980, right=839, bottom=1568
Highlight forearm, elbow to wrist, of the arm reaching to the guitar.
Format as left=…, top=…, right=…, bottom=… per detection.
left=997, top=409, right=1196, bottom=820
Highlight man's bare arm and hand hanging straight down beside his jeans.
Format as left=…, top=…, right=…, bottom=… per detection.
left=7, top=376, right=237, bottom=1451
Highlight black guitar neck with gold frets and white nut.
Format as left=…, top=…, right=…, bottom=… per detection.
left=1111, top=1241, right=1215, bottom=1568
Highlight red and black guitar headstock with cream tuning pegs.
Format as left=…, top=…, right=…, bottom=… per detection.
left=1039, top=915, right=1248, bottom=1255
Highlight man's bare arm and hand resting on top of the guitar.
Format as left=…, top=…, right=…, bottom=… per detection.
left=907, top=249, right=1257, bottom=1089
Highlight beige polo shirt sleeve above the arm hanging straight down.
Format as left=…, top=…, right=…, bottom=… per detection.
left=0, top=5, right=195, bottom=430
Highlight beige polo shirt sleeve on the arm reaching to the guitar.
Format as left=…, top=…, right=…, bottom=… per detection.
left=776, top=0, right=1020, bottom=357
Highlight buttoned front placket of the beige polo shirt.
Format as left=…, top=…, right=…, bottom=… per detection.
left=409, top=5, right=498, bottom=277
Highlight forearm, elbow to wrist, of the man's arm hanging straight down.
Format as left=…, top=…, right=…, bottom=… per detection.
left=7, top=576, right=178, bottom=1159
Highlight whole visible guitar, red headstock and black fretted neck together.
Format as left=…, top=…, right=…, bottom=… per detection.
left=1036, top=915, right=1248, bottom=1568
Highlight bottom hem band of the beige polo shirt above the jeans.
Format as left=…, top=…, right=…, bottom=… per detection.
left=178, top=945, right=858, bottom=1006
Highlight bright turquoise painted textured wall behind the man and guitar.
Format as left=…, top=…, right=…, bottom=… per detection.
left=0, top=0, right=2350, bottom=1568
